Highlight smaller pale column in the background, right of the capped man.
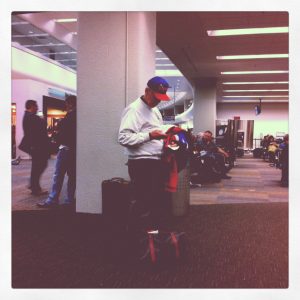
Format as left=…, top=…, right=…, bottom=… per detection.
left=193, top=78, right=217, bottom=135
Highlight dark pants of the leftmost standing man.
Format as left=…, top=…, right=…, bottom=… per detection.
left=30, top=150, right=49, bottom=193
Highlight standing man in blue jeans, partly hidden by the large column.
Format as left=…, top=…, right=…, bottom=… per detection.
left=37, top=95, right=76, bottom=208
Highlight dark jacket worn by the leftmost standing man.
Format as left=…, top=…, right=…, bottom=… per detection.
left=23, top=111, right=50, bottom=154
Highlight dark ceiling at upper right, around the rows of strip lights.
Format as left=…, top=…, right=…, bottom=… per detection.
left=157, top=12, right=289, bottom=102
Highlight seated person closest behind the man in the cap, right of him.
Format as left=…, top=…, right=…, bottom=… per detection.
left=197, top=130, right=231, bottom=179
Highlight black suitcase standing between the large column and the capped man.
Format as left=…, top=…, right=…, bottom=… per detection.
left=102, top=177, right=133, bottom=233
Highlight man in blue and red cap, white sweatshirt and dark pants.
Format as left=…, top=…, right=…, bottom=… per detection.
left=118, top=76, right=170, bottom=230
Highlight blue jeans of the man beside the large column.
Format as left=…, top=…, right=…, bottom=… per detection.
left=46, top=148, right=76, bottom=204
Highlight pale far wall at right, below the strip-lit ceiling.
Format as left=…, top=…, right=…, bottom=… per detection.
left=217, top=103, right=289, bottom=138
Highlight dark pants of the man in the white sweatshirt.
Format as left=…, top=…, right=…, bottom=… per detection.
left=128, top=159, right=171, bottom=230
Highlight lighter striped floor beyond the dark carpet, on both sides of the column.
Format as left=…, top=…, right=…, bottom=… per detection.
left=12, top=156, right=288, bottom=210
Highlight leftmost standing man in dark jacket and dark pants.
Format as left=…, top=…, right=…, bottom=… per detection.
left=23, top=100, right=50, bottom=196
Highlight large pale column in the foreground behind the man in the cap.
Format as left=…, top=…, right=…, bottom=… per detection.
left=76, top=12, right=156, bottom=213
